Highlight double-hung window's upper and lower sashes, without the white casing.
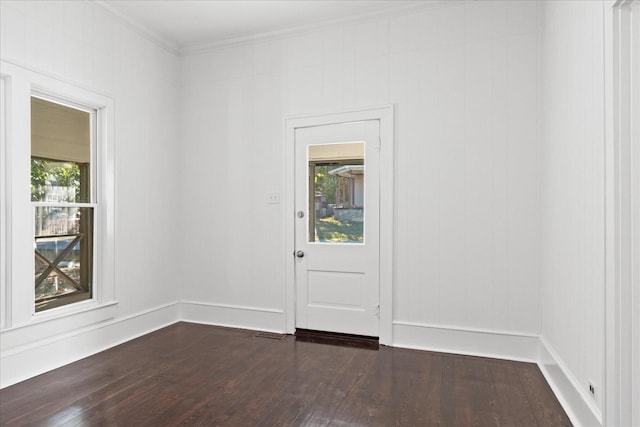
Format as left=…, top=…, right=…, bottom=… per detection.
left=31, top=96, right=96, bottom=312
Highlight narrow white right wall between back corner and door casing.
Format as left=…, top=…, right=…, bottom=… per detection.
left=540, top=1, right=605, bottom=422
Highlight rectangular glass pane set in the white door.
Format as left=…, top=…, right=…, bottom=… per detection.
left=308, top=142, right=365, bottom=243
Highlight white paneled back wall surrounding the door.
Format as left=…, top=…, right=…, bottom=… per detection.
left=180, top=1, right=540, bottom=346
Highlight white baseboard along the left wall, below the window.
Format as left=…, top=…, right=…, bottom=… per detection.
left=0, top=303, right=179, bottom=388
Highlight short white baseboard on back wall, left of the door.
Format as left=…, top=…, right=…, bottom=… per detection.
left=178, top=301, right=284, bottom=333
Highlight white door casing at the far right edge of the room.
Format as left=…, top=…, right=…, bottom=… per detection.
left=603, top=0, right=640, bottom=426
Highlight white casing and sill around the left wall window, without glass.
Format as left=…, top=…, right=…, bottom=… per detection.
left=0, top=61, right=117, bottom=340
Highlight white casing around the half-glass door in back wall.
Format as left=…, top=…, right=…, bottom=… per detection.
left=282, top=105, right=394, bottom=345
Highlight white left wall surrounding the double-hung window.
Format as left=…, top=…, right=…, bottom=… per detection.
left=0, top=1, right=180, bottom=385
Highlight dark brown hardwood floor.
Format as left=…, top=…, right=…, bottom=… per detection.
left=0, top=323, right=570, bottom=427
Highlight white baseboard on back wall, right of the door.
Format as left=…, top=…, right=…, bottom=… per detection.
left=393, top=321, right=540, bottom=363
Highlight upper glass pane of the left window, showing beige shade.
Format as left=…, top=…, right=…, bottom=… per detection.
left=31, top=97, right=91, bottom=203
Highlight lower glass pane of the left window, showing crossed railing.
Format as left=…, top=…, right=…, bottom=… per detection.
left=34, top=205, right=93, bottom=311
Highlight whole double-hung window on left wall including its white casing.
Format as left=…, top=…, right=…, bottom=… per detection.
left=0, top=61, right=117, bottom=328
